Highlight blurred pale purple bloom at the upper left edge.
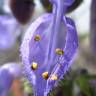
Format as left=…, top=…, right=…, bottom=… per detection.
left=0, top=15, right=20, bottom=50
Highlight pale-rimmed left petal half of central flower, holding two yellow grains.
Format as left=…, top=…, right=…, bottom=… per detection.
left=21, top=14, right=52, bottom=96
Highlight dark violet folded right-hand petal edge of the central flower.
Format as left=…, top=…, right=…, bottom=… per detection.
left=46, top=18, right=78, bottom=93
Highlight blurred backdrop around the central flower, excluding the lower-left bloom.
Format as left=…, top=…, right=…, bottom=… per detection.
left=0, top=0, right=96, bottom=96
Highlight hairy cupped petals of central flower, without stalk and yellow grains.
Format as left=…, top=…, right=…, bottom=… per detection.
left=20, top=14, right=78, bottom=96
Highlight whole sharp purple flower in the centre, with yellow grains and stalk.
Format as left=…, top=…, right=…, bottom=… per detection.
left=20, top=0, right=78, bottom=96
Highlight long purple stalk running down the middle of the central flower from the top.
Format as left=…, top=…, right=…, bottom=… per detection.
left=47, top=0, right=66, bottom=67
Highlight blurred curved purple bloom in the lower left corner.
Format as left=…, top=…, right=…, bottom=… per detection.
left=0, top=63, right=22, bottom=96
